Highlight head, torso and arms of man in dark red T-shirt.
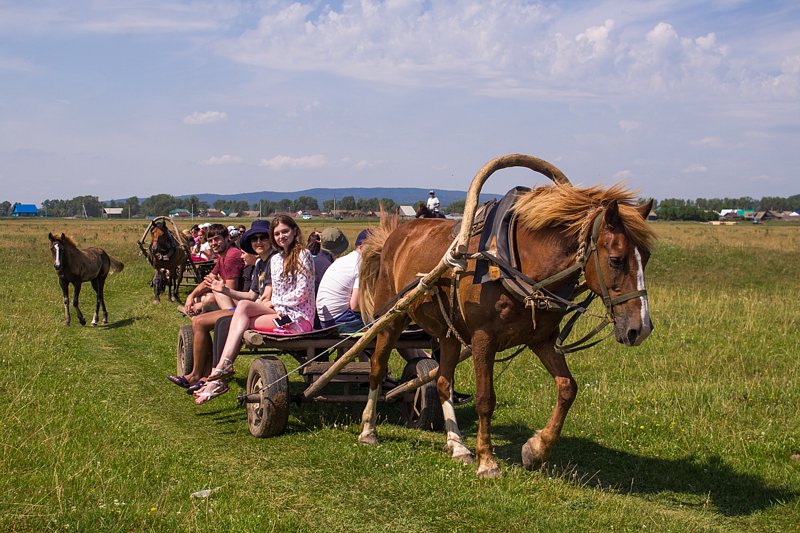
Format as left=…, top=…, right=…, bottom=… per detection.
left=184, top=224, right=244, bottom=316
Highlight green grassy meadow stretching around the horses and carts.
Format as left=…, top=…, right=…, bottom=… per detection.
left=0, top=219, right=800, bottom=532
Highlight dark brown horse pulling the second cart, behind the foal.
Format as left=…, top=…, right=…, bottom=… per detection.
left=149, top=219, right=189, bottom=303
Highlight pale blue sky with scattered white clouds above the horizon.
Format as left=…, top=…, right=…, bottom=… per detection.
left=0, top=0, right=800, bottom=203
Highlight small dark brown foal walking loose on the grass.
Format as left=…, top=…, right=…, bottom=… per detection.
left=47, top=233, right=125, bottom=326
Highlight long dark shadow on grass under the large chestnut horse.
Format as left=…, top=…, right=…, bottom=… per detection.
left=493, top=425, right=800, bottom=516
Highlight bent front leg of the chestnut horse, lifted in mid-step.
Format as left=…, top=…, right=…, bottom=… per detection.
left=522, top=338, right=578, bottom=470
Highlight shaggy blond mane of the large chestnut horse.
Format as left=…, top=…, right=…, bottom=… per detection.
left=514, top=184, right=655, bottom=250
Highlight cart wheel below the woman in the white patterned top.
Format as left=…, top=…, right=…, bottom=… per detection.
left=247, top=357, right=289, bottom=438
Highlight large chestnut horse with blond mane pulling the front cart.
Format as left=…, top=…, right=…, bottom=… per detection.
left=359, top=160, right=654, bottom=478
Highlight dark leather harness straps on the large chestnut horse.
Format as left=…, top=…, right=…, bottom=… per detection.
left=422, top=187, right=647, bottom=357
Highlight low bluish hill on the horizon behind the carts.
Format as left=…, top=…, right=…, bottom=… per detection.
left=178, top=187, right=502, bottom=207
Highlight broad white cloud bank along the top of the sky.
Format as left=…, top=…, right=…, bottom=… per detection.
left=218, top=0, right=800, bottom=99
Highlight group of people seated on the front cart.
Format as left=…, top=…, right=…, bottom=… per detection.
left=168, top=215, right=369, bottom=404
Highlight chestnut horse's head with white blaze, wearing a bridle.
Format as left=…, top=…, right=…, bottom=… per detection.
left=585, top=200, right=653, bottom=346
